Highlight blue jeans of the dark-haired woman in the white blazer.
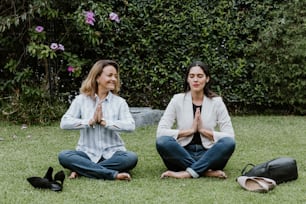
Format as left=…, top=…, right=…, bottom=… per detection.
left=156, top=136, right=236, bottom=178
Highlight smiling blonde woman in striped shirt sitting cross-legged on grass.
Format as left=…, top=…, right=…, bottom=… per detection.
left=58, top=60, right=138, bottom=180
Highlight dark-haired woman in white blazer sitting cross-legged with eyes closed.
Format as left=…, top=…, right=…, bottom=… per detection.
left=156, top=61, right=235, bottom=178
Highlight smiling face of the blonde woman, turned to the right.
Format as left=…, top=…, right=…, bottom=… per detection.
left=97, top=65, right=118, bottom=91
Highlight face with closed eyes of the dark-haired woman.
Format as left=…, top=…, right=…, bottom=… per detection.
left=187, top=66, right=209, bottom=92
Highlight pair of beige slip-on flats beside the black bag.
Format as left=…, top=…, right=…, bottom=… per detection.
left=237, top=176, right=276, bottom=193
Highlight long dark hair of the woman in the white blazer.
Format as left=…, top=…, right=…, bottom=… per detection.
left=184, top=61, right=218, bottom=98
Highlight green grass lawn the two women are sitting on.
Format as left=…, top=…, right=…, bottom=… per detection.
left=0, top=116, right=306, bottom=204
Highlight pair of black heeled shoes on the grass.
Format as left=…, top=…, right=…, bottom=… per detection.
left=27, top=167, right=65, bottom=191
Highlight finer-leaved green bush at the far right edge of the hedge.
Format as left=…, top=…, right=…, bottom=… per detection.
left=252, top=1, right=306, bottom=114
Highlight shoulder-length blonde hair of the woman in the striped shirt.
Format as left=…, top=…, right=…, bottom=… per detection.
left=80, top=60, right=120, bottom=97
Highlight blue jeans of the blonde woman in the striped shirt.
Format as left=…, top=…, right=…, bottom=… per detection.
left=58, top=150, right=138, bottom=180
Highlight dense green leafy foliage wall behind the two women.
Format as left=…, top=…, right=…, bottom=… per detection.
left=0, top=0, right=306, bottom=123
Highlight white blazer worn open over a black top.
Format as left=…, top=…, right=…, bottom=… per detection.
left=156, top=92, right=235, bottom=149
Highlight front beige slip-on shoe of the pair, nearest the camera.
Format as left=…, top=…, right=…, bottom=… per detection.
left=237, top=176, right=269, bottom=193
